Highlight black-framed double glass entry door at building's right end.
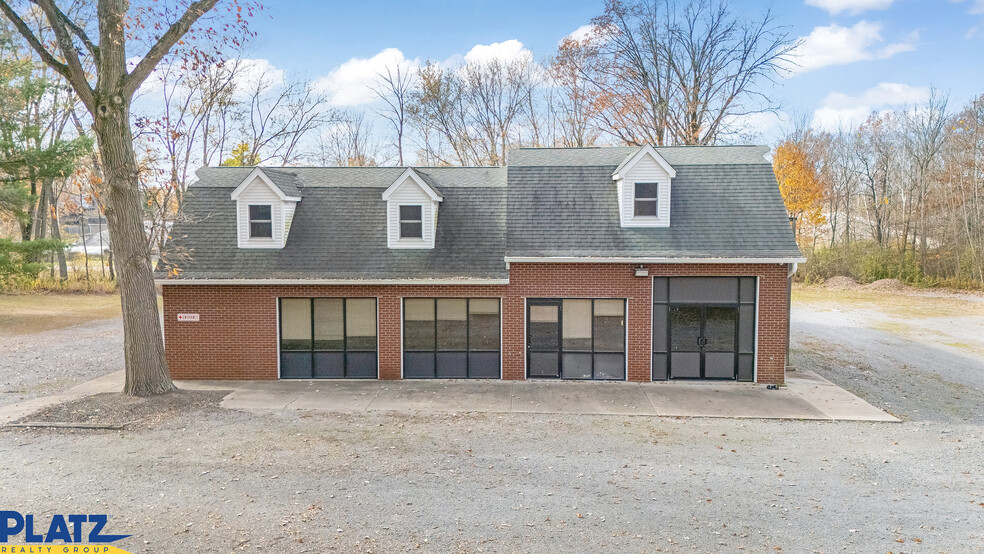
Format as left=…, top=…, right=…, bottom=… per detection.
left=669, top=305, right=738, bottom=379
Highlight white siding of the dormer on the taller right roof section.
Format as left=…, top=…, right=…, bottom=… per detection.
left=612, top=146, right=676, bottom=227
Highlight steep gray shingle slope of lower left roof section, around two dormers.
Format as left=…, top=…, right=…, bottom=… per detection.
left=166, top=183, right=507, bottom=279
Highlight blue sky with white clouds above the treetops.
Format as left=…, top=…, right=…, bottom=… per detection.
left=225, top=0, right=984, bottom=140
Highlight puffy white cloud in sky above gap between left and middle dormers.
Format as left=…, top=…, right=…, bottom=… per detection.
left=312, top=48, right=420, bottom=106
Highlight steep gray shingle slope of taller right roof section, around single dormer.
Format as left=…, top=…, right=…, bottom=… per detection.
left=506, top=163, right=801, bottom=258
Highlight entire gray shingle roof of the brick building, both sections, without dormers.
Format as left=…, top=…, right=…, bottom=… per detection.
left=158, top=146, right=801, bottom=280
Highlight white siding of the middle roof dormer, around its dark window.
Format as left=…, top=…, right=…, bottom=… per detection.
left=383, top=169, right=444, bottom=249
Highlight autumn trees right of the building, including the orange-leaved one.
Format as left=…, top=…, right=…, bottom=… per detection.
left=774, top=90, right=984, bottom=287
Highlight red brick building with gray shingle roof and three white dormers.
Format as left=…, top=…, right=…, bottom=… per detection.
left=158, top=146, right=803, bottom=383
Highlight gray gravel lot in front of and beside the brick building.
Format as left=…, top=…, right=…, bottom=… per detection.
left=0, top=290, right=984, bottom=552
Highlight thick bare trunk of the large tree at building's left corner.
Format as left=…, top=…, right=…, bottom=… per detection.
left=93, top=98, right=174, bottom=396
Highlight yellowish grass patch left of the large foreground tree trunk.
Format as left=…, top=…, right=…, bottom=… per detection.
left=0, top=294, right=120, bottom=335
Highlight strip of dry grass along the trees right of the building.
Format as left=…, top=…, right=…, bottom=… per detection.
left=793, top=285, right=984, bottom=318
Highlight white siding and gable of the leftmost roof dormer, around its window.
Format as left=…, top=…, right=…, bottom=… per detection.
left=232, top=168, right=301, bottom=249
